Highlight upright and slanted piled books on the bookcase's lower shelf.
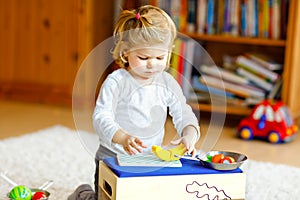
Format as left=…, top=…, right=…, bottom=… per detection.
left=170, top=43, right=281, bottom=105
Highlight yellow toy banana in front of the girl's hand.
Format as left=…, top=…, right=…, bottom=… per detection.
left=152, top=143, right=187, bottom=161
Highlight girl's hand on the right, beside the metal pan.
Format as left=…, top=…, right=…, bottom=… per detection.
left=171, top=126, right=197, bottom=156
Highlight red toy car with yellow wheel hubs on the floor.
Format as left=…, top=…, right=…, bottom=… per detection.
left=238, top=100, right=298, bottom=143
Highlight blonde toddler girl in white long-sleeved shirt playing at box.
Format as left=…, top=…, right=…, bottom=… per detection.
left=69, top=5, right=200, bottom=200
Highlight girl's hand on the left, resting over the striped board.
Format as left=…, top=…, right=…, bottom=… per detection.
left=112, top=130, right=147, bottom=155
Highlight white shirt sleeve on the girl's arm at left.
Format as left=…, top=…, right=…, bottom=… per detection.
left=93, top=76, right=120, bottom=145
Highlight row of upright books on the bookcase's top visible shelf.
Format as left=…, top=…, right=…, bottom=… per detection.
left=151, top=0, right=289, bottom=39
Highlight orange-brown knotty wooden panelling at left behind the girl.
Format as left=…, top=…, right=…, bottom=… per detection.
left=0, top=0, right=113, bottom=105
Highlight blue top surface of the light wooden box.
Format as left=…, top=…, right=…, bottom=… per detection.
left=103, top=158, right=243, bottom=178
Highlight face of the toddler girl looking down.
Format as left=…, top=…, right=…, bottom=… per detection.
left=127, top=46, right=169, bottom=80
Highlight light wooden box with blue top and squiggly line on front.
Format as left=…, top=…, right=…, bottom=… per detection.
left=99, top=158, right=246, bottom=200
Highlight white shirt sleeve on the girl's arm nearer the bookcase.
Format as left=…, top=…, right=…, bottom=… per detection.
left=166, top=74, right=200, bottom=141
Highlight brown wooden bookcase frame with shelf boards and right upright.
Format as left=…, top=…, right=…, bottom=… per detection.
left=119, top=0, right=300, bottom=118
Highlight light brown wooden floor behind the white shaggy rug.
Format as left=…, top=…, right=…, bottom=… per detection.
left=0, top=100, right=300, bottom=168
